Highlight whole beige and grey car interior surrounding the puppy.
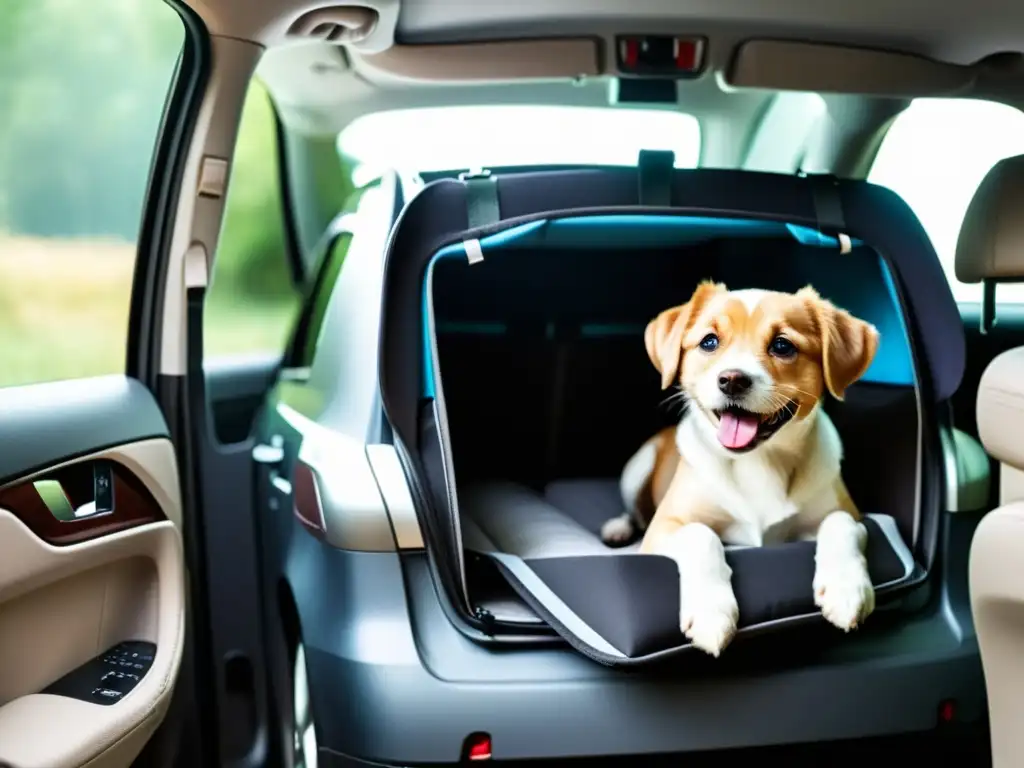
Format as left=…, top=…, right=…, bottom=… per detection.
left=8, top=0, right=1024, bottom=768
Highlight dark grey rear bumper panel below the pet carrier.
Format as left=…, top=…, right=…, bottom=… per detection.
left=286, top=518, right=984, bottom=765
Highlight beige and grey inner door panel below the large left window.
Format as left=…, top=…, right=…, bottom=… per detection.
left=0, top=377, right=185, bottom=768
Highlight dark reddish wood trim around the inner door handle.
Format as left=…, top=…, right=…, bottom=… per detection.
left=0, top=458, right=167, bottom=547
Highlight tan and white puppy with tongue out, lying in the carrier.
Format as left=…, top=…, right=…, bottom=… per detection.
left=601, top=281, right=879, bottom=656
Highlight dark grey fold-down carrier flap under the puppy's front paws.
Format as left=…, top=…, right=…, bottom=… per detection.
left=525, top=518, right=909, bottom=658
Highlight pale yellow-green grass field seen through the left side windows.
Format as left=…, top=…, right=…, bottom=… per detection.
left=0, top=233, right=296, bottom=386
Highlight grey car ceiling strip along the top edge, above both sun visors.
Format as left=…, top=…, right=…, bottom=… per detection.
left=187, top=0, right=1024, bottom=65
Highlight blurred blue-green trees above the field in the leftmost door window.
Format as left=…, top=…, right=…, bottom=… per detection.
left=0, top=0, right=184, bottom=241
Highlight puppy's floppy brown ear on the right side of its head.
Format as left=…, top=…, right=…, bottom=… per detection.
left=799, top=288, right=879, bottom=400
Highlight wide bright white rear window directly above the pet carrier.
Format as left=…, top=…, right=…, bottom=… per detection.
left=338, top=104, right=700, bottom=179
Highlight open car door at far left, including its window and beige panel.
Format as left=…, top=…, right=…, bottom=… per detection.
left=0, top=0, right=197, bottom=768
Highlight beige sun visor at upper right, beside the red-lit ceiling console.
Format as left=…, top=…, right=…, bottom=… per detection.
left=725, top=40, right=976, bottom=98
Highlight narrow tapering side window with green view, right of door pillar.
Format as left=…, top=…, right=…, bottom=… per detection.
left=203, top=79, right=301, bottom=358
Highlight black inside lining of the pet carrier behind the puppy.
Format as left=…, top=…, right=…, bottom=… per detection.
left=432, top=239, right=919, bottom=542
